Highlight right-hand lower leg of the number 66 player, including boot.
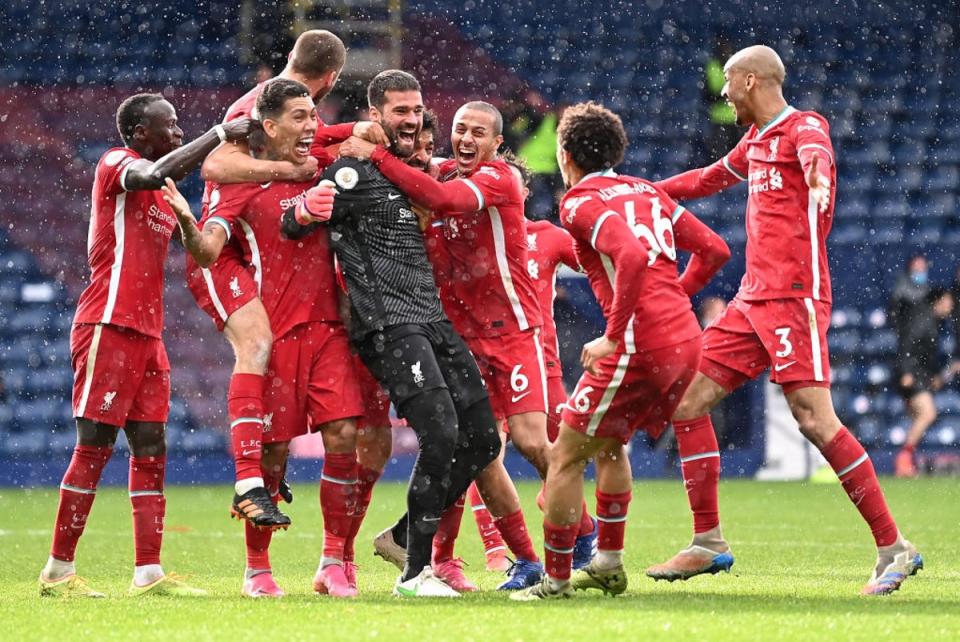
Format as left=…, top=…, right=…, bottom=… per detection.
left=571, top=440, right=633, bottom=595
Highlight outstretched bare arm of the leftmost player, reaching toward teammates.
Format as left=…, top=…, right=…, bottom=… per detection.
left=121, top=118, right=258, bottom=192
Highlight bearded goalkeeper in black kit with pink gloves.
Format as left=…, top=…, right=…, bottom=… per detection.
left=281, top=70, right=500, bottom=597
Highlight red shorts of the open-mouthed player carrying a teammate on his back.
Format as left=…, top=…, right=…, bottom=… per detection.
left=263, top=321, right=363, bottom=444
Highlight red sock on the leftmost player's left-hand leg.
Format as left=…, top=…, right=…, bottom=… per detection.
left=50, top=446, right=113, bottom=562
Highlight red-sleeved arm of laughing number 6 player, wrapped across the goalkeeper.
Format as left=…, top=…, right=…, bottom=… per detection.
left=340, top=137, right=484, bottom=214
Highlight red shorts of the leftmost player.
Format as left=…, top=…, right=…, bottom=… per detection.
left=70, top=323, right=170, bottom=427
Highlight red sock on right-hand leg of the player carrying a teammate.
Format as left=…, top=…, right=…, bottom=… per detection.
left=320, top=451, right=358, bottom=561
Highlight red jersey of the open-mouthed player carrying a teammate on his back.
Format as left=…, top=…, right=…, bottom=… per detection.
left=206, top=182, right=340, bottom=338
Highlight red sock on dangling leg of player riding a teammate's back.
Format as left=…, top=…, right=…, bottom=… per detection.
left=227, top=373, right=263, bottom=481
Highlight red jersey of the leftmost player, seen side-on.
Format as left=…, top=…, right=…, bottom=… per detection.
left=74, top=147, right=177, bottom=338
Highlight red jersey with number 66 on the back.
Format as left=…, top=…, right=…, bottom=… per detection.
left=560, top=171, right=700, bottom=354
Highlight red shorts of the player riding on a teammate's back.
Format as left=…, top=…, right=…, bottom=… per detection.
left=187, top=251, right=260, bottom=332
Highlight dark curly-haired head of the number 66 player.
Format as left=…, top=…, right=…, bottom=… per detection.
left=557, top=102, right=628, bottom=174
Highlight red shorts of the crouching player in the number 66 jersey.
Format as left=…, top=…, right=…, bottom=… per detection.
left=561, top=337, right=700, bottom=444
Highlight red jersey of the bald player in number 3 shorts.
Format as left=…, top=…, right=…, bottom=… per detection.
left=723, top=106, right=837, bottom=301
